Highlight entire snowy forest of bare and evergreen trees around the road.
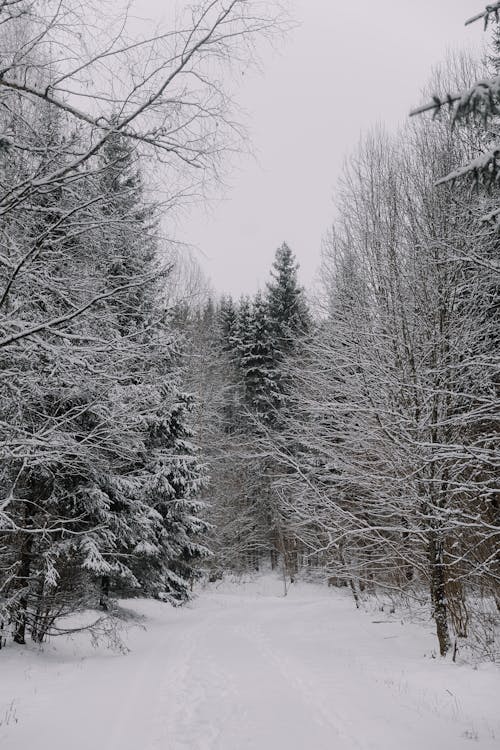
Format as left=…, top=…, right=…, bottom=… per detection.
left=0, top=0, right=500, bottom=661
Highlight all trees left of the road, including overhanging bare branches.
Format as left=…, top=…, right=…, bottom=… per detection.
left=0, top=0, right=277, bottom=646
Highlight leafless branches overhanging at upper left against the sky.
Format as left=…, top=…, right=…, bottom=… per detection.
left=0, top=0, right=281, bottom=347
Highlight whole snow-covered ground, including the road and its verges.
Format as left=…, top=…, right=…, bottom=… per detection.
left=0, top=576, right=500, bottom=750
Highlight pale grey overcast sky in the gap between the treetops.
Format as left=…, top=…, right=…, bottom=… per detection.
left=149, top=0, right=485, bottom=296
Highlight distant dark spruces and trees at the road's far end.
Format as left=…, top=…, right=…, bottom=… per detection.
left=176, top=243, right=312, bottom=578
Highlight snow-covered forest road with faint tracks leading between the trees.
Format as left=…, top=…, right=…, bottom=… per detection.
left=112, top=586, right=500, bottom=750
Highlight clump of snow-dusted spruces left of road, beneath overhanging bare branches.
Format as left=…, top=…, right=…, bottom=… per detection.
left=0, top=107, right=211, bottom=643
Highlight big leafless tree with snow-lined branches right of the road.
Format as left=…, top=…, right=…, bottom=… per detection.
left=270, top=54, right=500, bottom=654
